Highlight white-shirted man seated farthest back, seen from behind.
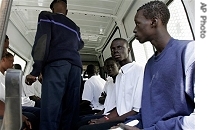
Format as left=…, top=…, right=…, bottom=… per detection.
left=80, top=65, right=106, bottom=115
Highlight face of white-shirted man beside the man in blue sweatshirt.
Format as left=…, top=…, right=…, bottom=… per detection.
left=110, top=40, right=130, bottom=61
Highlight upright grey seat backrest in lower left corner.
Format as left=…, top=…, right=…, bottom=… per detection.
left=1, top=69, right=22, bottom=130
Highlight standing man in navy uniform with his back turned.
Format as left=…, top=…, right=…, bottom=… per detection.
left=26, top=0, right=84, bottom=130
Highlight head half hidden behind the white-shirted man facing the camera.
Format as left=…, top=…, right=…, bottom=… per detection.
left=104, top=57, right=120, bottom=77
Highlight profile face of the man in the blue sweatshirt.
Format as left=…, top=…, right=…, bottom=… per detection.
left=133, top=10, right=152, bottom=43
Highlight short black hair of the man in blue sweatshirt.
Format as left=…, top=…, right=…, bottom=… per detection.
left=137, top=0, right=170, bottom=25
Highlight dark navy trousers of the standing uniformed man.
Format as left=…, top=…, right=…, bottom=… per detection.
left=40, top=60, right=81, bottom=130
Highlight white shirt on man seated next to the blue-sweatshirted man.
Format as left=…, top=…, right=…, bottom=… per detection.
left=115, top=61, right=144, bottom=116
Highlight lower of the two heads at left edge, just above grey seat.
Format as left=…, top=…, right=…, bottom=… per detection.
left=0, top=52, right=14, bottom=73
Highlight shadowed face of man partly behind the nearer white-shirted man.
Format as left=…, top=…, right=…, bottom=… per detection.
left=105, top=60, right=119, bottom=77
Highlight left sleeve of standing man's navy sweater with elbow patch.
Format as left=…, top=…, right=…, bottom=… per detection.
left=30, top=11, right=51, bottom=76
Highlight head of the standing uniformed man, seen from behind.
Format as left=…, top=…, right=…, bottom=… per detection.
left=51, top=0, right=68, bottom=15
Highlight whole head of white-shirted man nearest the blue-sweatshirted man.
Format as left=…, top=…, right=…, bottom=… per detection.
left=110, top=38, right=131, bottom=66
